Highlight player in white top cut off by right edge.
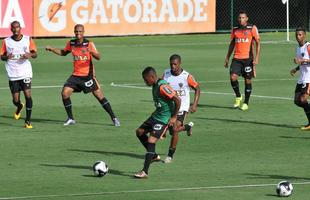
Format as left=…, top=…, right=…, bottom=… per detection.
left=291, top=27, right=310, bottom=130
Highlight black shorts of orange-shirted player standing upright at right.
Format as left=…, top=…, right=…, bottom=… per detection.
left=230, top=58, right=254, bottom=79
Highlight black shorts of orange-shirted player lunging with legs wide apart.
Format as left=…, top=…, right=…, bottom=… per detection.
left=64, top=75, right=100, bottom=93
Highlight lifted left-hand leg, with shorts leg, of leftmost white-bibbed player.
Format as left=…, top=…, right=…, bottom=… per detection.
left=9, top=81, right=24, bottom=119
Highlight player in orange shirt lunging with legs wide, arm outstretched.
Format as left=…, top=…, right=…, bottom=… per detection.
left=46, top=24, right=120, bottom=126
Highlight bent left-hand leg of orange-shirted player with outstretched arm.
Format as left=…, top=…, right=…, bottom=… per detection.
left=61, top=86, right=75, bottom=126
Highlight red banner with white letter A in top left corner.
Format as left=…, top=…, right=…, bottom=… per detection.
left=0, top=0, right=33, bottom=37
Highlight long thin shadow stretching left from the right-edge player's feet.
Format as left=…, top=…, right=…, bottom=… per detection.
left=195, top=117, right=298, bottom=129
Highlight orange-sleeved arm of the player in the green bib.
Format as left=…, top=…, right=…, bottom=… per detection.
left=159, top=85, right=181, bottom=126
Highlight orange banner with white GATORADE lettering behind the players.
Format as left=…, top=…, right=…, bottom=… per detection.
left=34, top=0, right=216, bottom=36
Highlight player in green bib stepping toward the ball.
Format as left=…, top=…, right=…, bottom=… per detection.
left=134, top=67, right=181, bottom=178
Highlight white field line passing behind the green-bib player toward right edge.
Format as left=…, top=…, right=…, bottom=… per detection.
left=111, top=83, right=293, bottom=100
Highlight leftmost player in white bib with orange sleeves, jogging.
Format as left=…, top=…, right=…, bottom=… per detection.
left=0, top=21, right=37, bottom=128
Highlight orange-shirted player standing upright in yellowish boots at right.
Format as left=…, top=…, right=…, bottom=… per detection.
left=224, top=11, right=260, bottom=111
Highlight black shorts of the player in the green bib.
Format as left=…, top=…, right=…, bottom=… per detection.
left=139, top=117, right=168, bottom=139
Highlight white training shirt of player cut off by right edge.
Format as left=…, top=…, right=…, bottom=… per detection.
left=296, top=42, right=310, bottom=84
